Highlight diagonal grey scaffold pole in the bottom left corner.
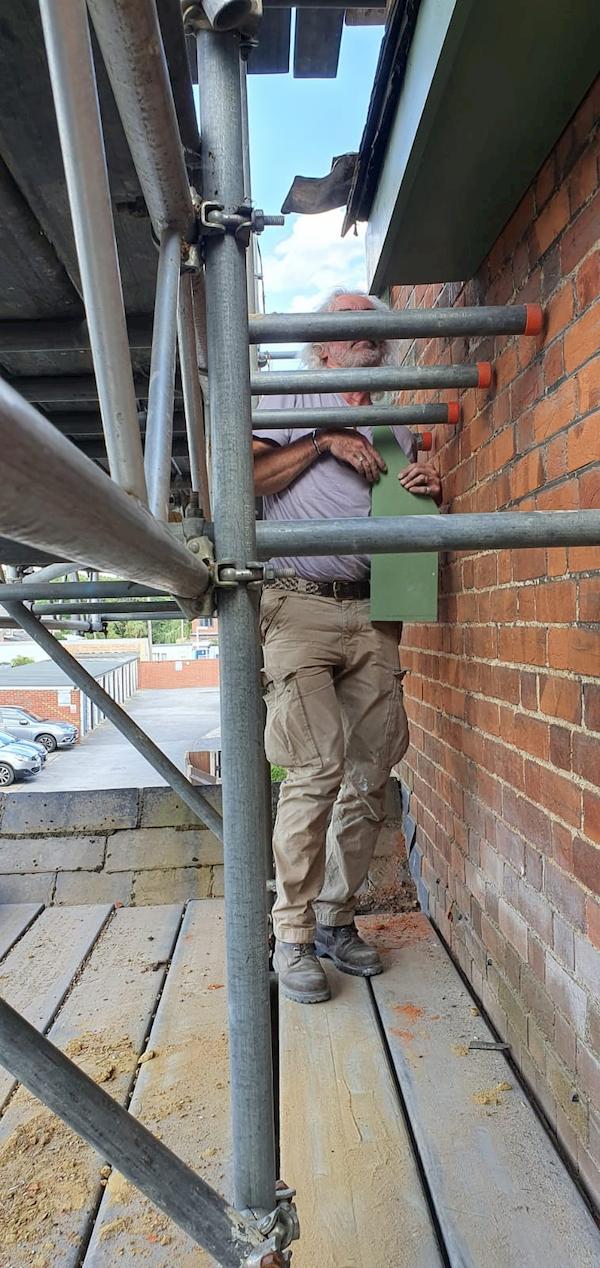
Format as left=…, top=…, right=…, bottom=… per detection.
left=0, top=999, right=261, bottom=1268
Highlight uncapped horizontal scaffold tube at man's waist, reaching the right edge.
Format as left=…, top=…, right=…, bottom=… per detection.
left=256, top=511, right=600, bottom=559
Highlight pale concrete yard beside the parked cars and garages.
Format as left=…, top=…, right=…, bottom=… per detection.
left=8, top=687, right=221, bottom=793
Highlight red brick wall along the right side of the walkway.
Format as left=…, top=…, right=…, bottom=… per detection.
left=393, top=84, right=600, bottom=1200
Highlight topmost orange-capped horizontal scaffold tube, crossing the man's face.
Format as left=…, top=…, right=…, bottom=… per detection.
left=250, top=304, right=543, bottom=344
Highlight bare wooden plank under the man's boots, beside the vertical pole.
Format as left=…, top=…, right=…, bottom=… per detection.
left=279, top=964, right=441, bottom=1268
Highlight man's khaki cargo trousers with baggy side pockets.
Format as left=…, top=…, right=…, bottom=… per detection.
left=260, top=586, right=408, bottom=942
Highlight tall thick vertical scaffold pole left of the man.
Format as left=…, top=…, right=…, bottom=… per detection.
left=197, top=22, right=275, bottom=1210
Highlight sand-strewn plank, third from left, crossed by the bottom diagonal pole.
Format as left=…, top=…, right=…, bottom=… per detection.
left=0, top=904, right=181, bottom=1268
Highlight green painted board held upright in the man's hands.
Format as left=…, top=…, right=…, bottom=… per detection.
left=370, top=427, right=439, bottom=621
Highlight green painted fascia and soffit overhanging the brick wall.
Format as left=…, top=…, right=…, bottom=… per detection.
left=367, top=0, right=600, bottom=293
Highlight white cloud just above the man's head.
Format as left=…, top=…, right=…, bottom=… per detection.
left=263, top=208, right=367, bottom=312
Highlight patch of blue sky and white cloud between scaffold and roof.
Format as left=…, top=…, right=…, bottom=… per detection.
left=247, top=27, right=383, bottom=312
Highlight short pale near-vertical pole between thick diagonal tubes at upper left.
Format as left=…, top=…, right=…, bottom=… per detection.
left=143, top=230, right=181, bottom=521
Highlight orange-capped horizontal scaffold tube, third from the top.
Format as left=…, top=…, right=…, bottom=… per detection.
left=252, top=401, right=459, bottom=431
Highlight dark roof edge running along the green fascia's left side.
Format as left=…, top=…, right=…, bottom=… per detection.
left=341, top=0, right=421, bottom=235
